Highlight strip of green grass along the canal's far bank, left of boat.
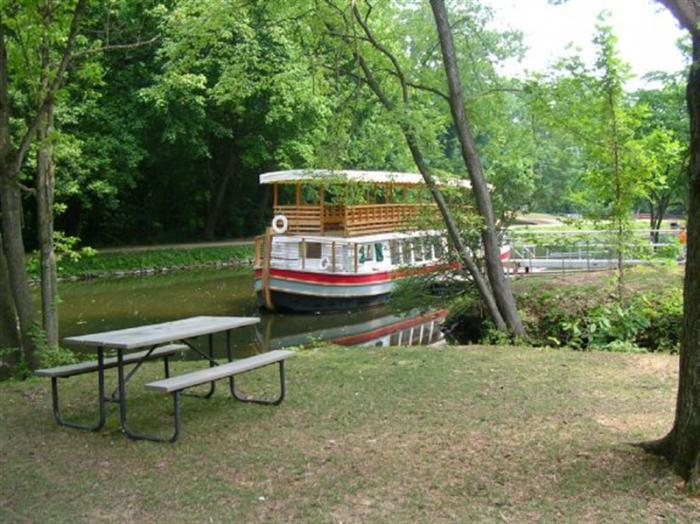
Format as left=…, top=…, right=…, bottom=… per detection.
left=29, top=246, right=253, bottom=278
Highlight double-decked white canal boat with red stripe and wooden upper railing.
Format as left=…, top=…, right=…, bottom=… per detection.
left=255, top=169, right=508, bottom=312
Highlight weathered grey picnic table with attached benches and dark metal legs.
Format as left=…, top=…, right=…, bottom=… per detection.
left=35, top=316, right=294, bottom=442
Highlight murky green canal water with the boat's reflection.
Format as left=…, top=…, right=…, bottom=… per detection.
left=59, top=269, right=444, bottom=356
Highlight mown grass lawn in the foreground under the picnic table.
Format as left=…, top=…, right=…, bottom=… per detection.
left=0, top=346, right=700, bottom=523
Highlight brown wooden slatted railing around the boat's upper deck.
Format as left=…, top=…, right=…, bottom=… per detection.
left=274, top=204, right=434, bottom=237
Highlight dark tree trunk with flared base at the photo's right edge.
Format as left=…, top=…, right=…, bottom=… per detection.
left=644, top=4, right=700, bottom=482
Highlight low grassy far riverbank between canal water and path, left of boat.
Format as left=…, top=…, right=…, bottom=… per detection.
left=29, top=245, right=253, bottom=281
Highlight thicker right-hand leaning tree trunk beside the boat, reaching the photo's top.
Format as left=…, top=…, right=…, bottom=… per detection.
left=430, top=0, right=524, bottom=336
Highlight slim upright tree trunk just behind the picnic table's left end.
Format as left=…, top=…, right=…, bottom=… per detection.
left=36, top=104, right=58, bottom=349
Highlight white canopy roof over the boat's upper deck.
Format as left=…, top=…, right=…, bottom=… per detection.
left=260, top=169, right=471, bottom=189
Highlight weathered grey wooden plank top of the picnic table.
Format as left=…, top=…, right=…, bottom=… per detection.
left=63, top=316, right=260, bottom=349
